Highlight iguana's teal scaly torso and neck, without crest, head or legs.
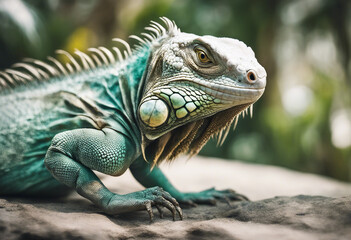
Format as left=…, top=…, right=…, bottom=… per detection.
left=0, top=45, right=149, bottom=194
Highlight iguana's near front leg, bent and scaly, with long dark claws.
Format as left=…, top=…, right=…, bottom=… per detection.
left=45, top=128, right=181, bottom=219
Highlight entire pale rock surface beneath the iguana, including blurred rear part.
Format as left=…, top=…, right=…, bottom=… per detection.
left=0, top=157, right=351, bottom=240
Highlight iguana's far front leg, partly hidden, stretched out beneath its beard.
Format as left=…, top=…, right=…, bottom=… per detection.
left=130, top=158, right=248, bottom=206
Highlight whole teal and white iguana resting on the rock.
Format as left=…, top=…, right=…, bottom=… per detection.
left=0, top=17, right=266, bottom=220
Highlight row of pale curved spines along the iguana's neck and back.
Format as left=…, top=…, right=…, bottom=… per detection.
left=0, top=17, right=180, bottom=90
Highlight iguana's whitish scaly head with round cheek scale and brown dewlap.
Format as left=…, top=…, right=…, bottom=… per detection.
left=138, top=17, right=267, bottom=164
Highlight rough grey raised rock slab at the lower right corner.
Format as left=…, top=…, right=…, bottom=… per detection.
left=223, top=195, right=351, bottom=239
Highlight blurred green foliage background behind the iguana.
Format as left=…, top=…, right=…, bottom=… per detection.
left=0, top=0, right=351, bottom=181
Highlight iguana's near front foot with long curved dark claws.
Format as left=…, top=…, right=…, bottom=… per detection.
left=103, top=187, right=183, bottom=222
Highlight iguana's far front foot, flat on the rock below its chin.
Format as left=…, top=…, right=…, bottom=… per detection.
left=177, top=188, right=250, bottom=206
